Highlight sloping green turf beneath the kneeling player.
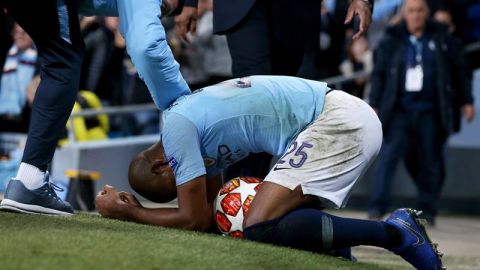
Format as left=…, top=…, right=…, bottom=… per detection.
left=0, top=212, right=394, bottom=270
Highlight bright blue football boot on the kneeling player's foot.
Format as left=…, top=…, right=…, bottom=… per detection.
left=385, top=209, right=446, bottom=270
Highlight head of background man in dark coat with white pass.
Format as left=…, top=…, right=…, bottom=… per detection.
left=403, top=0, right=429, bottom=32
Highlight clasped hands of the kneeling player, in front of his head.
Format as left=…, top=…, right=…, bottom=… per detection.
left=95, top=185, right=138, bottom=219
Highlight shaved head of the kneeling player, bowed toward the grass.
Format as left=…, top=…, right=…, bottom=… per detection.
left=128, top=142, right=177, bottom=203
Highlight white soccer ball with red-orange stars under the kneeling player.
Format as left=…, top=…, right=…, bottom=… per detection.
left=215, top=176, right=262, bottom=238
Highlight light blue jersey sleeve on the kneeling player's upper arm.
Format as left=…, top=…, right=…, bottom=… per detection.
left=162, top=112, right=206, bottom=186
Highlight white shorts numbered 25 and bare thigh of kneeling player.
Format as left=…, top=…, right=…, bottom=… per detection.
left=245, top=91, right=388, bottom=243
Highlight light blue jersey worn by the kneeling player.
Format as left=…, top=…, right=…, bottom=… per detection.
left=161, top=76, right=327, bottom=185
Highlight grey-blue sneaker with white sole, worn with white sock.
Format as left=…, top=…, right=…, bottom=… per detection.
left=0, top=173, right=73, bottom=216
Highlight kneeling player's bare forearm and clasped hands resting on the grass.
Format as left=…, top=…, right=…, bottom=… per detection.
left=96, top=176, right=213, bottom=231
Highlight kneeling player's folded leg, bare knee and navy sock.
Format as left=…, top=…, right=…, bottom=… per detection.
left=245, top=182, right=401, bottom=253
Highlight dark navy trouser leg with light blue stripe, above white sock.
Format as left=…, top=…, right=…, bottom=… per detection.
left=2, top=0, right=84, bottom=170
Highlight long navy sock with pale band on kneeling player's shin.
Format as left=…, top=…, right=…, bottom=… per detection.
left=244, top=209, right=401, bottom=252
